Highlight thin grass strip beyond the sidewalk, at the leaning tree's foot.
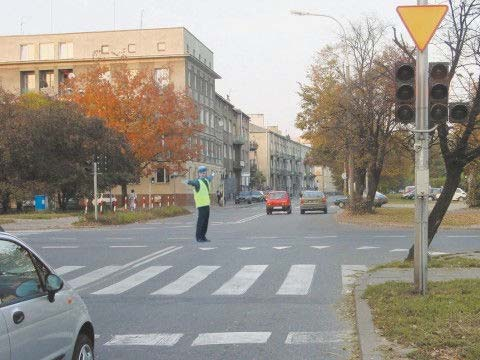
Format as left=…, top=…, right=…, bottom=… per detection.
left=370, top=255, right=480, bottom=271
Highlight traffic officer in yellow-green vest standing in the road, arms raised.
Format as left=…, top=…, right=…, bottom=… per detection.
left=184, top=165, right=215, bottom=242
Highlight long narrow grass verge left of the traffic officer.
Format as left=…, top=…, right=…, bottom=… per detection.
left=74, top=206, right=190, bottom=226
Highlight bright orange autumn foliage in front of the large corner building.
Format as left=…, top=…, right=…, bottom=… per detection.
left=62, top=63, right=201, bottom=171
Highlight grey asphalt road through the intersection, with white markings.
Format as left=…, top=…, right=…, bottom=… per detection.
left=14, top=201, right=480, bottom=360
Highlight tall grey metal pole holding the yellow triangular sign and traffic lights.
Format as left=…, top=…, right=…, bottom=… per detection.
left=414, top=0, right=430, bottom=295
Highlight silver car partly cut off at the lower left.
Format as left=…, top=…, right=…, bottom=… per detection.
left=0, top=232, right=95, bottom=360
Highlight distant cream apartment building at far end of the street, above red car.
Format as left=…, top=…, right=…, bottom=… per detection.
left=250, top=114, right=315, bottom=195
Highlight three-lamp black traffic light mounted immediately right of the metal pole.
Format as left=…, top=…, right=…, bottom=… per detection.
left=428, top=62, right=449, bottom=124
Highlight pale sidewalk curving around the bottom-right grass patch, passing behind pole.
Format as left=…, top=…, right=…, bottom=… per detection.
left=354, top=268, right=480, bottom=360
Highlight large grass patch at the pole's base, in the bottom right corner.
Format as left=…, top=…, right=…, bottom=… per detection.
left=364, top=279, right=480, bottom=360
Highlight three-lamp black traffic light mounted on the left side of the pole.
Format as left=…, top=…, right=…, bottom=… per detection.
left=395, top=63, right=415, bottom=124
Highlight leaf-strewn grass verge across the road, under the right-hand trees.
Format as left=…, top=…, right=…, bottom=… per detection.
left=337, top=208, right=480, bottom=227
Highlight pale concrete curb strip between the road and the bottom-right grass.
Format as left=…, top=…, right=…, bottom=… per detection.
left=353, top=273, right=384, bottom=360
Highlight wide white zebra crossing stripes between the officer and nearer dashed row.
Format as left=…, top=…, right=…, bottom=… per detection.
left=56, top=264, right=363, bottom=296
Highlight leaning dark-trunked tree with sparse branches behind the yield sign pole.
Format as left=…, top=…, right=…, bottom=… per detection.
left=394, top=0, right=480, bottom=259
